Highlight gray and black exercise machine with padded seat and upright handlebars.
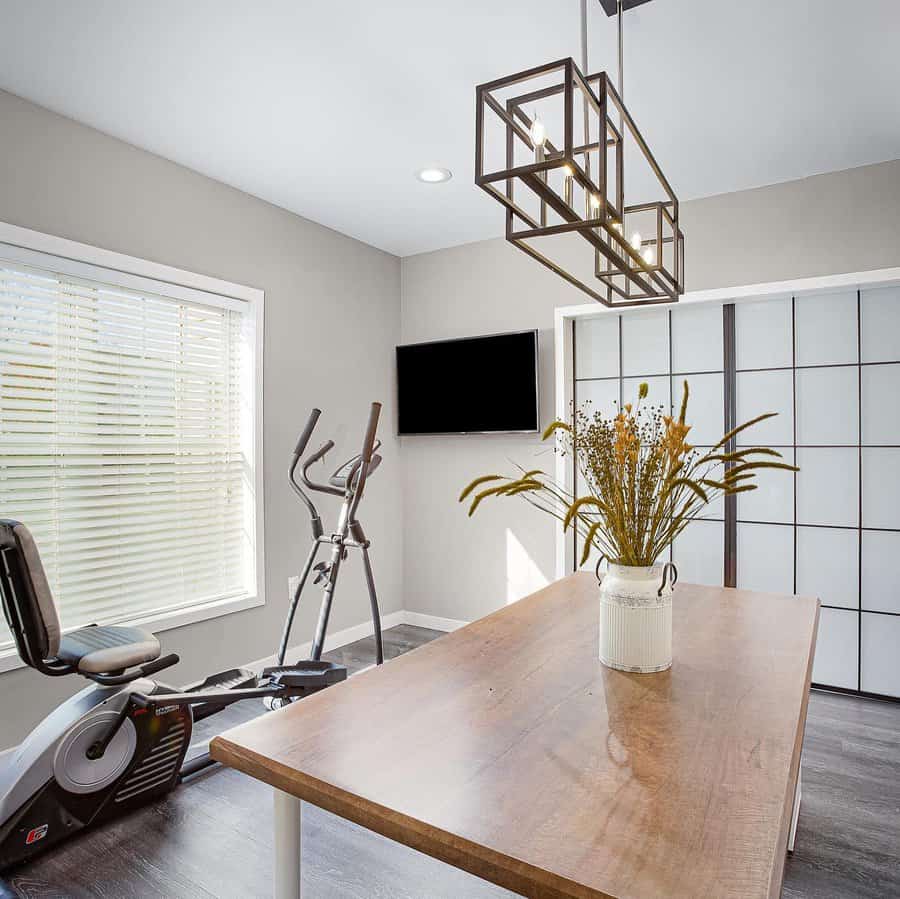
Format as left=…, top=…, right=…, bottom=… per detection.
left=0, top=403, right=383, bottom=870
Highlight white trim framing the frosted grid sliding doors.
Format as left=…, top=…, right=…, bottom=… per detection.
left=553, top=268, right=900, bottom=578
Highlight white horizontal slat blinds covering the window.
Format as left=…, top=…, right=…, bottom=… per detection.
left=0, top=256, right=252, bottom=644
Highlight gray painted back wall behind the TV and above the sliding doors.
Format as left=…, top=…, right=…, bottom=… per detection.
left=401, top=161, right=900, bottom=619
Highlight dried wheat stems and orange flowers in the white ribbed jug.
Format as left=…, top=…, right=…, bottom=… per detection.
left=459, top=381, right=798, bottom=566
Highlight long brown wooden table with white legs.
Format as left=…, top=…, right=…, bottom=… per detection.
left=211, top=574, right=819, bottom=899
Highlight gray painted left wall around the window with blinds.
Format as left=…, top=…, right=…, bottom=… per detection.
left=0, top=92, right=402, bottom=749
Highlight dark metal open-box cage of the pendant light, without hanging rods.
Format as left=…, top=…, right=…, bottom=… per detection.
left=475, top=58, right=684, bottom=307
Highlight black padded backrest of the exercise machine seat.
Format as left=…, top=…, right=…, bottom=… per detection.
left=0, top=519, right=60, bottom=668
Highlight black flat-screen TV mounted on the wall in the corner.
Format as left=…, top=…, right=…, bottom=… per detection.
left=397, top=331, right=538, bottom=434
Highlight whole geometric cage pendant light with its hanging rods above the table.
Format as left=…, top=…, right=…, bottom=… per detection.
left=475, top=0, right=684, bottom=307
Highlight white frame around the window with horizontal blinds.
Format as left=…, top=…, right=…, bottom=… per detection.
left=0, top=222, right=266, bottom=673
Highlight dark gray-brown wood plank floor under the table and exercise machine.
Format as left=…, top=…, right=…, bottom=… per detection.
left=0, top=625, right=900, bottom=899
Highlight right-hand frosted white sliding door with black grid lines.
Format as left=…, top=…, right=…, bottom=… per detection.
left=735, top=288, right=900, bottom=696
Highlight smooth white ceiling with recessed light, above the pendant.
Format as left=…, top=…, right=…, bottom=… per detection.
left=0, top=0, right=900, bottom=255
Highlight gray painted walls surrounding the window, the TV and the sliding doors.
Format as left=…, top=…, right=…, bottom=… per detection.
left=0, top=84, right=900, bottom=748
